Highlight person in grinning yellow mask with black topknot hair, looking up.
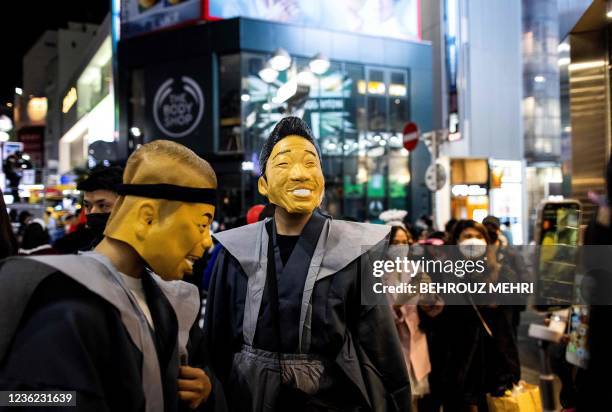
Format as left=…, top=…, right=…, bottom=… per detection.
left=204, top=117, right=411, bottom=412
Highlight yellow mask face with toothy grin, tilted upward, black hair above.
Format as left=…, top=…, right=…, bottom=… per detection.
left=259, top=136, right=325, bottom=214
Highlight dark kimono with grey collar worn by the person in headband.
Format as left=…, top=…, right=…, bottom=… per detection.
left=0, top=253, right=225, bottom=411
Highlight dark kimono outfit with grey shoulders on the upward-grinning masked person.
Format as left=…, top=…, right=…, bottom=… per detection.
left=204, top=212, right=411, bottom=412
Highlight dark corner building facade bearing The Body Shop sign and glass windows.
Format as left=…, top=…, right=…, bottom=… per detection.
left=113, top=18, right=433, bottom=224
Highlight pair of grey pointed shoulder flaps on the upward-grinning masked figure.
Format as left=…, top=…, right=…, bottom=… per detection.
left=213, top=219, right=391, bottom=280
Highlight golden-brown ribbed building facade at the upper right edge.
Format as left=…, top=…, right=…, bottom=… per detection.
left=559, top=0, right=612, bottom=224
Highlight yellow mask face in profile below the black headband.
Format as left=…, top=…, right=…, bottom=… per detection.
left=138, top=202, right=215, bottom=280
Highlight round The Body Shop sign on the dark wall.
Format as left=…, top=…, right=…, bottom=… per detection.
left=152, top=76, right=204, bottom=138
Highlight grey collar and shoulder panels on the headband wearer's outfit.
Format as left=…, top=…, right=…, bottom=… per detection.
left=0, top=252, right=200, bottom=412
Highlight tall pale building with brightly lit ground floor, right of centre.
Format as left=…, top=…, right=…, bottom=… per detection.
left=423, top=0, right=526, bottom=243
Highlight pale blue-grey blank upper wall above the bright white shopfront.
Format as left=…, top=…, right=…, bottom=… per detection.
left=441, top=0, right=523, bottom=160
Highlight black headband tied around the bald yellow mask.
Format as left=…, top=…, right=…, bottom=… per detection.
left=117, top=183, right=217, bottom=205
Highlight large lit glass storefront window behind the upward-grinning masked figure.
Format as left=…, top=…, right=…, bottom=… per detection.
left=234, top=53, right=410, bottom=220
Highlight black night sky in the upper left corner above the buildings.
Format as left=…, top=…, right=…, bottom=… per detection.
left=0, top=0, right=111, bottom=112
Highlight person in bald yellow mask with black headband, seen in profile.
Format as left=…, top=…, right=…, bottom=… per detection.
left=0, top=140, right=222, bottom=411
